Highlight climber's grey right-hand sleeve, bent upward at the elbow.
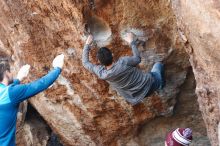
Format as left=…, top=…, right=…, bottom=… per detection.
left=122, top=41, right=141, bottom=66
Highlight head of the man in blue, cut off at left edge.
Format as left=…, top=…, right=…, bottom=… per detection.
left=0, top=58, right=13, bottom=84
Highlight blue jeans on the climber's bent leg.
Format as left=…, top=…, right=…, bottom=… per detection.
left=147, top=62, right=164, bottom=96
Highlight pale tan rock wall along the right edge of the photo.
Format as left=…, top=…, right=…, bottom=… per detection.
left=172, top=0, right=220, bottom=146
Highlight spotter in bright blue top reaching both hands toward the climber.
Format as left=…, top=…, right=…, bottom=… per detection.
left=0, top=54, right=64, bottom=146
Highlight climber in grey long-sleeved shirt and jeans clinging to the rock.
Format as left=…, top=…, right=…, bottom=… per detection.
left=82, top=33, right=164, bottom=105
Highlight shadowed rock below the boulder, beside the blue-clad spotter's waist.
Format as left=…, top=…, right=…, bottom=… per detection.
left=16, top=105, right=62, bottom=146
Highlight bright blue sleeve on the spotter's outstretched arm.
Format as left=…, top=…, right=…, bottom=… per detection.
left=8, top=67, right=61, bottom=104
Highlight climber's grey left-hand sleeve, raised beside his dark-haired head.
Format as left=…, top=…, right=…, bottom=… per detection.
left=82, top=44, right=103, bottom=78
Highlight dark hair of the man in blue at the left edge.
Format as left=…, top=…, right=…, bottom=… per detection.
left=0, top=58, right=10, bottom=81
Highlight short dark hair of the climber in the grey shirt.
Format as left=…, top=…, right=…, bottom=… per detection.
left=97, top=47, right=113, bottom=66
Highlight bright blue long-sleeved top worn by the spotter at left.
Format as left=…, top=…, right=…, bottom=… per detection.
left=0, top=68, right=61, bottom=146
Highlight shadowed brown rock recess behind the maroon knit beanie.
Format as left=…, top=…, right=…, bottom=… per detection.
left=135, top=70, right=211, bottom=146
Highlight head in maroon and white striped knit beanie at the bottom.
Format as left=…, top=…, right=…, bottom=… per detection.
left=165, top=128, right=192, bottom=146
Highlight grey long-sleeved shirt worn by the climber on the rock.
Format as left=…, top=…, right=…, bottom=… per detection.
left=82, top=41, right=154, bottom=105
